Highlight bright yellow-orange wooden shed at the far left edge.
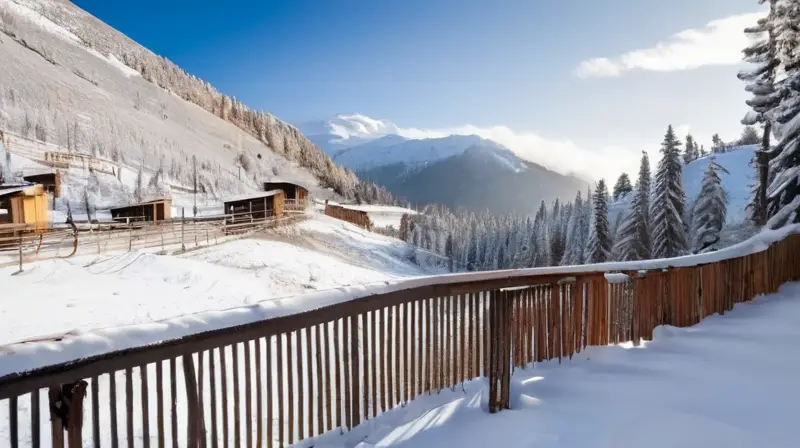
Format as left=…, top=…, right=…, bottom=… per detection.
left=0, top=185, right=50, bottom=230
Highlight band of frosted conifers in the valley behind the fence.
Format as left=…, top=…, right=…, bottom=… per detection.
left=398, top=122, right=727, bottom=270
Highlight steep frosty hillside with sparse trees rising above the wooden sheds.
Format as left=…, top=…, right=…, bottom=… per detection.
left=0, top=0, right=357, bottom=207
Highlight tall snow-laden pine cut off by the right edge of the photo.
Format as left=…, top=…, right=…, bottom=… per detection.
left=767, top=0, right=800, bottom=228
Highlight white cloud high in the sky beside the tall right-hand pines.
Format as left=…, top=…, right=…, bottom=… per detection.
left=575, top=12, right=765, bottom=78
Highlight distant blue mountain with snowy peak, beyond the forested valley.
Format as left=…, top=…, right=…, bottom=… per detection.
left=300, top=114, right=588, bottom=214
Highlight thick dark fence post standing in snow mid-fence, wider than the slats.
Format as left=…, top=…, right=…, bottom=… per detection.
left=487, top=290, right=514, bottom=413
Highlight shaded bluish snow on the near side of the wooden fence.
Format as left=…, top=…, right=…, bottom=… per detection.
left=314, top=283, right=800, bottom=448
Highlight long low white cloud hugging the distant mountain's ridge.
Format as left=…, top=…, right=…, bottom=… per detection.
left=329, top=114, right=641, bottom=182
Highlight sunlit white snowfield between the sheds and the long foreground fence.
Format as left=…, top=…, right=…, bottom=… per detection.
left=0, top=216, right=440, bottom=345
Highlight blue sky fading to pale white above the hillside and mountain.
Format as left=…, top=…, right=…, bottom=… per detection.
left=75, top=0, right=762, bottom=180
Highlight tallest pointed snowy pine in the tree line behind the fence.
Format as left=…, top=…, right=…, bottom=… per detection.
left=650, top=125, right=689, bottom=258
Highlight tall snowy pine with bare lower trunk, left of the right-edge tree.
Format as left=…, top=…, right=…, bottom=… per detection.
left=738, top=0, right=780, bottom=226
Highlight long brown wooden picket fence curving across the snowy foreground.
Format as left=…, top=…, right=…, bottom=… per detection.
left=0, top=235, right=800, bottom=448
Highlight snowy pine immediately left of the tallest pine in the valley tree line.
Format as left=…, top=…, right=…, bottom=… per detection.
left=614, top=151, right=652, bottom=261
